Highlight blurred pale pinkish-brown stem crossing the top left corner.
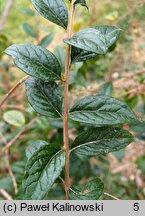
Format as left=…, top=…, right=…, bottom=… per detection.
left=0, top=0, right=14, bottom=32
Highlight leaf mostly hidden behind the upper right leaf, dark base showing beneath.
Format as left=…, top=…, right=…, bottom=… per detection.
left=71, top=25, right=121, bottom=62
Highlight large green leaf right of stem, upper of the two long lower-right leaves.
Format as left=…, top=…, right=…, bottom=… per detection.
left=69, top=95, right=137, bottom=126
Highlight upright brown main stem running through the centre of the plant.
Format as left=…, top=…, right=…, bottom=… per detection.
left=63, top=0, right=75, bottom=200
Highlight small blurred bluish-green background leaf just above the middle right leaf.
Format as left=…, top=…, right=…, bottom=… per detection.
left=98, top=82, right=113, bottom=96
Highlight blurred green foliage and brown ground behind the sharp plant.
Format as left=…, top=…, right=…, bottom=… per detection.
left=0, top=0, right=145, bottom=199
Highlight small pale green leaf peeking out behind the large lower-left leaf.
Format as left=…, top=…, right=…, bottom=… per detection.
left=26, top=140, right=47, bottom=159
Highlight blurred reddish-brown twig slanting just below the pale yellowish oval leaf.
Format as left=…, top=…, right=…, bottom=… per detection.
left=0, top=116, right=38, bottom=157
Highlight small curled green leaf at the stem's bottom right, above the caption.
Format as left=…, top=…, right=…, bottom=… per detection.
left=69, top=178, right=104, bottom=200
